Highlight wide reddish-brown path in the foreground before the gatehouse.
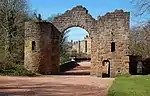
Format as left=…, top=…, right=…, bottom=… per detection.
left=0, top=75, right=114, bottom=96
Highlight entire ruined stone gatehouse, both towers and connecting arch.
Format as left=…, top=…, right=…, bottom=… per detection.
left=25, top=6, right=130, bottom=77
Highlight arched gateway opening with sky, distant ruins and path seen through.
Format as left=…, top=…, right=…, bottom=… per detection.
left=60, top=27, right=91, bottom=75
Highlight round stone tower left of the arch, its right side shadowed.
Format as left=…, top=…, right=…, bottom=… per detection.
left=24, top=22, right=60, bottom=74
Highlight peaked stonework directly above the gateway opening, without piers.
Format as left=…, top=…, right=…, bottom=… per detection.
left=52, top=6, right=96, bottom=36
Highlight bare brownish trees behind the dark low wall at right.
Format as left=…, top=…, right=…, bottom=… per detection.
left=130, top=22, right=150, bottom=57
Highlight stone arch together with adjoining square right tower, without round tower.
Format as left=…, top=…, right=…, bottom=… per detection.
left=53, top=6, right=130, bottom=77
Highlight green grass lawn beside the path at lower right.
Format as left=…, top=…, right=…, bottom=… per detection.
left=108, top=75, right=150, bottom=96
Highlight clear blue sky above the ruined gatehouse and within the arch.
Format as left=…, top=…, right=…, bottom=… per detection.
left=28, top=0, right=134, bottom=40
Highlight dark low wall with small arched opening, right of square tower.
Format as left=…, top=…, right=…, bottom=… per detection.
left=129, top=56, right=150, bottom=75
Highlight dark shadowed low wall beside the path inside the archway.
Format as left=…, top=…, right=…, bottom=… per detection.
left=60, top=61, right=80, bottom=72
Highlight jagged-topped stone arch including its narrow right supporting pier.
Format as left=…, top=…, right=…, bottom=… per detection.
left=52, top=6, right=98, bottom=75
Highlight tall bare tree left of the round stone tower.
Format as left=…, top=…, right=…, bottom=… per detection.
left=0, top=0, right=28, bottom=65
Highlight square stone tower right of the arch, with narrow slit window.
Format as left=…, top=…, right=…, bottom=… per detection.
left=96, top=10, right=130, bottom=77
